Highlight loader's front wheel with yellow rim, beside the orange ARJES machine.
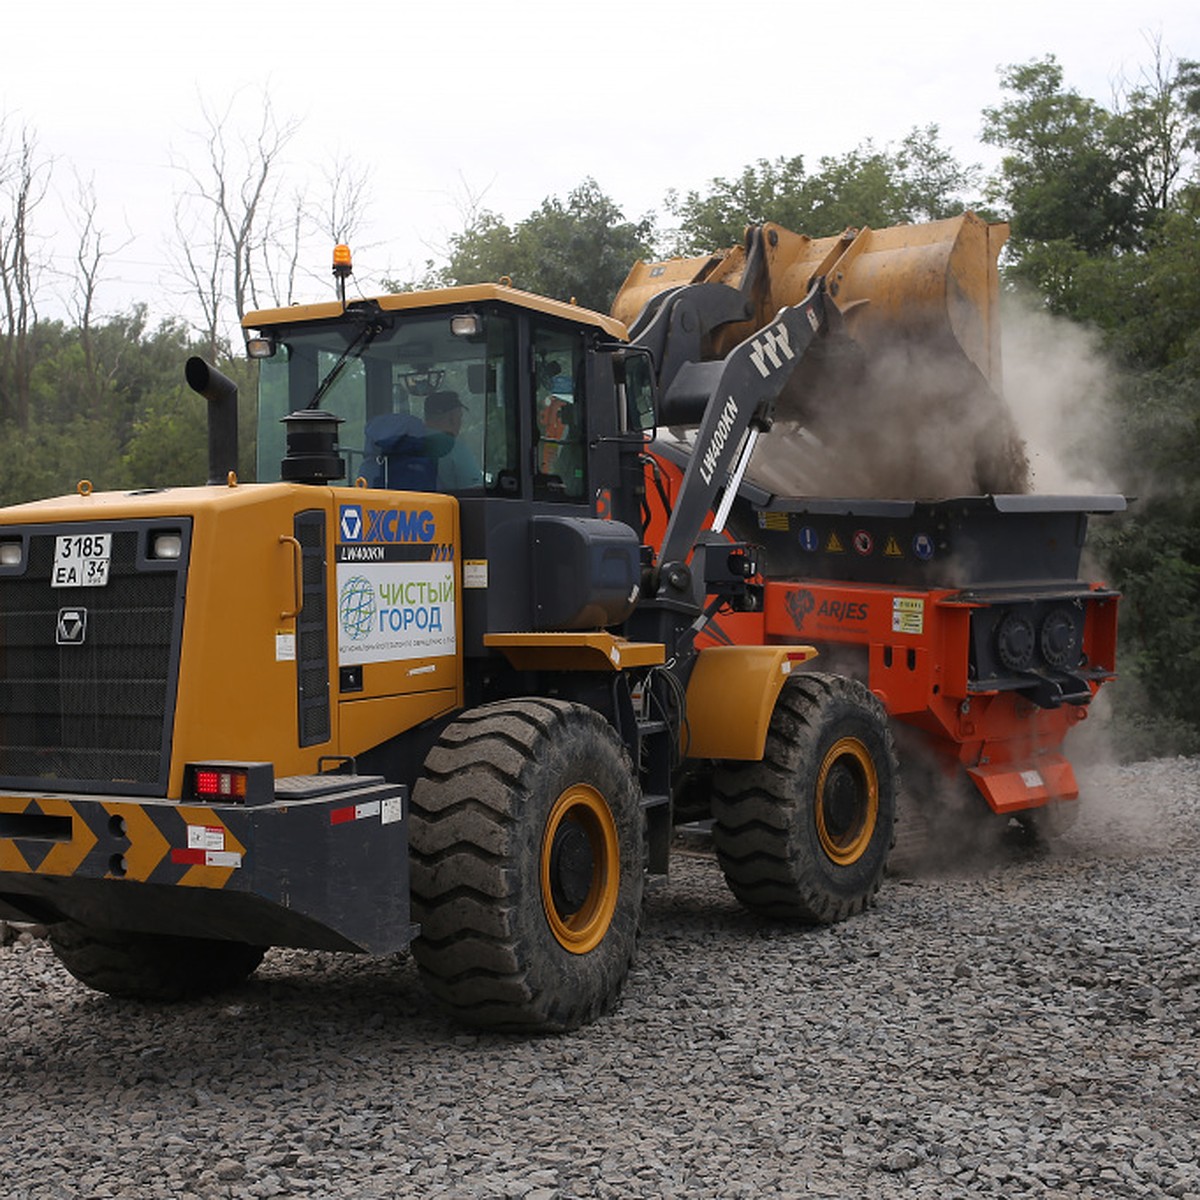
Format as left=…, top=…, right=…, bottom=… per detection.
left=713, top=673, right=899, bottom=925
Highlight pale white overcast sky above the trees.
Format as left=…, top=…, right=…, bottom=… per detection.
left=0, top=0, right=1200, bottom=324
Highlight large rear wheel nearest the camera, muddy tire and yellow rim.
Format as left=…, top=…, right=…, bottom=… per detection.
left=409, top=698, right=646, bottom=1032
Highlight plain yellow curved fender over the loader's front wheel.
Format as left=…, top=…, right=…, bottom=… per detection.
left=684, top=646, right=817, bottom=762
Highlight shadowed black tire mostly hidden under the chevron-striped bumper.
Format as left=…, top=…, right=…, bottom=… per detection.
left=47, top=920, right=266, bottom=1000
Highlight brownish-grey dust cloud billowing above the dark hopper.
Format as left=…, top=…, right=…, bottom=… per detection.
left=750, top=294, right=1121, bottom=499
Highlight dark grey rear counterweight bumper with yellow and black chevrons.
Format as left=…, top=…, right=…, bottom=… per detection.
left=0, top=776, right=413, bottom=954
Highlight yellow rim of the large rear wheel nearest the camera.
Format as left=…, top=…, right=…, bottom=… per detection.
left=541, top=784, right=620, bottom=954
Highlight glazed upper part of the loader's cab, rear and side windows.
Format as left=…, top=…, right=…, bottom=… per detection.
left=248, top=289, right=604, bottom=503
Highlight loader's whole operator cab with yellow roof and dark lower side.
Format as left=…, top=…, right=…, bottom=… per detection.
left=244, top=284, right=646, bottom=658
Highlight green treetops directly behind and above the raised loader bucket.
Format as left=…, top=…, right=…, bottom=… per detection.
left=667, top=125, right=978, bottom=254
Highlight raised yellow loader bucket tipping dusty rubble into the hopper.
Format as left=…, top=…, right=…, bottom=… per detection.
left=613, top=212, right=1028, bottom=498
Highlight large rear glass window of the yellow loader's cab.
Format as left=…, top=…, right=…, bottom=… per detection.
left=258, top=312, right=518, bottom=494
